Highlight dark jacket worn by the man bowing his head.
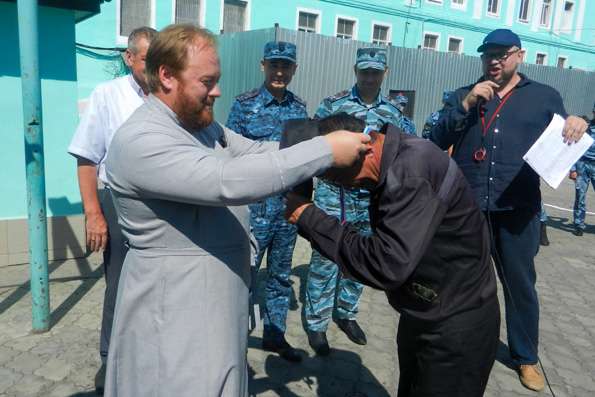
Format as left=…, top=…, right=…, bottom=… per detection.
left=298, top=126, right=496, bottom=322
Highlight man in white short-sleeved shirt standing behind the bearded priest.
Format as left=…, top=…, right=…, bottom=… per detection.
left=68, top=27, right=157, bottom=394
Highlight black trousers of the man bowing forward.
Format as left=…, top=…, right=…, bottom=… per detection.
left=397, top=297, right=500, bottom=397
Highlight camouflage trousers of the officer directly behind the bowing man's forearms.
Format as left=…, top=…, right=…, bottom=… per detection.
left=304, top=180, right=370, bottom=332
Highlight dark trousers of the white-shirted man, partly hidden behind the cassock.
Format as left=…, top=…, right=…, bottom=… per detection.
left=99, top=188, right=128, bottom=364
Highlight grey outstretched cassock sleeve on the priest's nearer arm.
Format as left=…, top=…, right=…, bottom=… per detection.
left=107, top=132, right=333, bottom=206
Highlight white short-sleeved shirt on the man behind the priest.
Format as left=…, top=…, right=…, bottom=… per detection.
left=68, top=75, right=145, bottom=183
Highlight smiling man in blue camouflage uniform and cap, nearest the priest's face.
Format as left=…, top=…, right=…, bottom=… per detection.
left=227, top=42, right=308, bottom=361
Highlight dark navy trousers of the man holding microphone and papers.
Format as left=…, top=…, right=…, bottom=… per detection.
left=486, top=209, right=540, bottom=365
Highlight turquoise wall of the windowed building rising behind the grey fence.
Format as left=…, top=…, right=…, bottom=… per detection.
left=76, top=0, right=595, bottom=104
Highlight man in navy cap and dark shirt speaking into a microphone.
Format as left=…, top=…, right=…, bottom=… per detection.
left=430, top=29, right=587, bottom=391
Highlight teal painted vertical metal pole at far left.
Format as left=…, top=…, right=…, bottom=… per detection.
left=17, top=0, right=50, bottom=333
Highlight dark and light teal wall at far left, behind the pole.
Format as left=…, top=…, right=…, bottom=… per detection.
left=0, top=2, right=81, bottom=219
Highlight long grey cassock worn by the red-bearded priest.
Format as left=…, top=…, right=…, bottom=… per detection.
left=105, top=96, right=332, bottom=397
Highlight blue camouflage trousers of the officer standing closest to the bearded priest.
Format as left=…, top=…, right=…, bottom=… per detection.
left=250, top=196, right=297, bottom=338
